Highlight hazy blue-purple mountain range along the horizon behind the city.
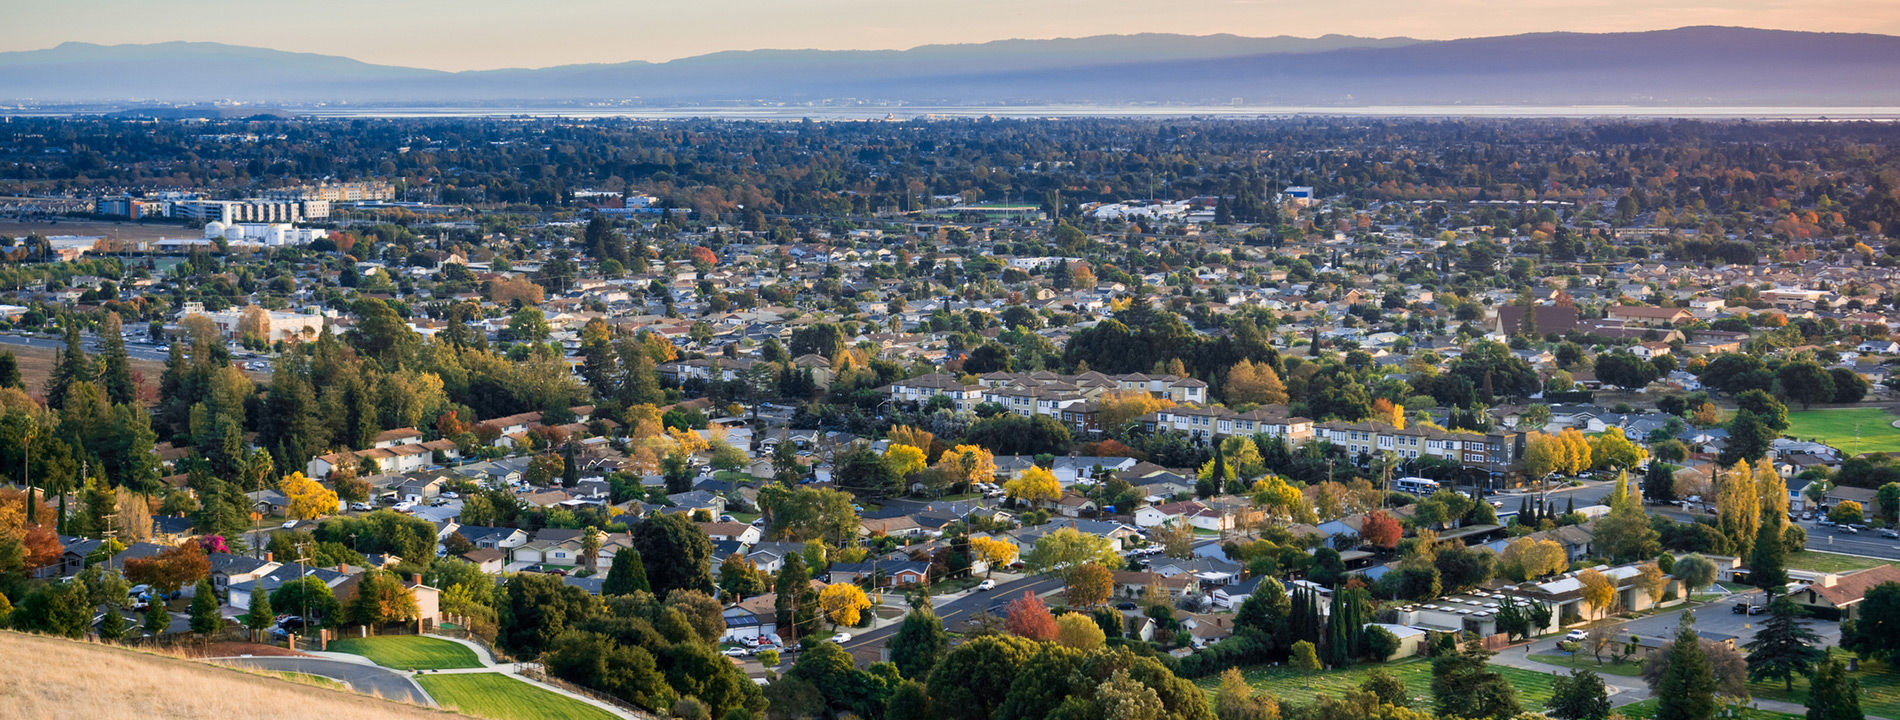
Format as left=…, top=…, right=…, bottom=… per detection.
left=0, top=27, right=1900, bottom=108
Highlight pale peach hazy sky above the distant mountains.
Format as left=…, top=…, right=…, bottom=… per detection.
left=0, top=0, right=1900, bottom=70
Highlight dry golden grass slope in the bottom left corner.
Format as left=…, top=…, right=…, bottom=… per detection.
left=0, top=633, right=473, bottom=720
